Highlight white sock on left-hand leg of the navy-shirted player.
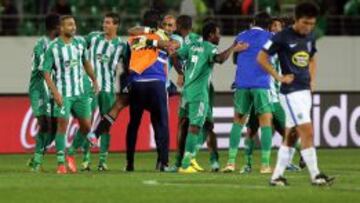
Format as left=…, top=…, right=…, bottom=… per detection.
left=271, top=145, right=290, bottom=180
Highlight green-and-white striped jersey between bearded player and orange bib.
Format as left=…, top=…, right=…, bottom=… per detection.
left=86, top=32, right=128, bottom=92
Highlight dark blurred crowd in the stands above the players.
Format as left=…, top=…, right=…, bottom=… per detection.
left=0, top=0, right=360, bottom=36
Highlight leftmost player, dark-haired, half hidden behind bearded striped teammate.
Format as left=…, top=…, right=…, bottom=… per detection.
left=29, top=14, right=60, bottom=172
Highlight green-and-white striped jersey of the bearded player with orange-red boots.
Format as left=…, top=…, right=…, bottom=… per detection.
left=42, top=36, right=88, bottom=97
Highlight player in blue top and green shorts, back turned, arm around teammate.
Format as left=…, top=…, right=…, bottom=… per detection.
left=223, top=12, right=272, bottom=173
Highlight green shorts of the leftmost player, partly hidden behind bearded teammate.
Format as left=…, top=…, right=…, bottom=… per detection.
left=29, top=88, right=51, bottom=117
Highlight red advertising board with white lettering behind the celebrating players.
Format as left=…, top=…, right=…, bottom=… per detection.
left=0, top=96, right=178, bottom=153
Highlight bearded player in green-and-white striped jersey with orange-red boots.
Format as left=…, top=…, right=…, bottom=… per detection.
left=43, top=15, right=99, bottom=174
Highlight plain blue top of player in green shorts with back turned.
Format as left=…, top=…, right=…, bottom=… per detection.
left=235, top=27, right=272, bottom=89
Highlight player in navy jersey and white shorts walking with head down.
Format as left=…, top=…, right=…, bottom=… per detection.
left=258, top=2, right=334, bottom=186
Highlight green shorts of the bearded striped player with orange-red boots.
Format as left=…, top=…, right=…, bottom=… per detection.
left=54, top=95, right=92, bottom=119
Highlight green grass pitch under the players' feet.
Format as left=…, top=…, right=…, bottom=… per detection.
left=0, top=149, right=360, bottom=203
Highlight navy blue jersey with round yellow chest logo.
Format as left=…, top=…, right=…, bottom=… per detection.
left=263, top=27, right=316, bottom=94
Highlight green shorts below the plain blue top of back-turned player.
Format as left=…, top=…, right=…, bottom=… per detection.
left=234, top=88, right=272, bottom=115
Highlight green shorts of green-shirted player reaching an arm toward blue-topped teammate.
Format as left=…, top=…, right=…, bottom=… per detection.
left=186, top=101, right=209, bottom=128
